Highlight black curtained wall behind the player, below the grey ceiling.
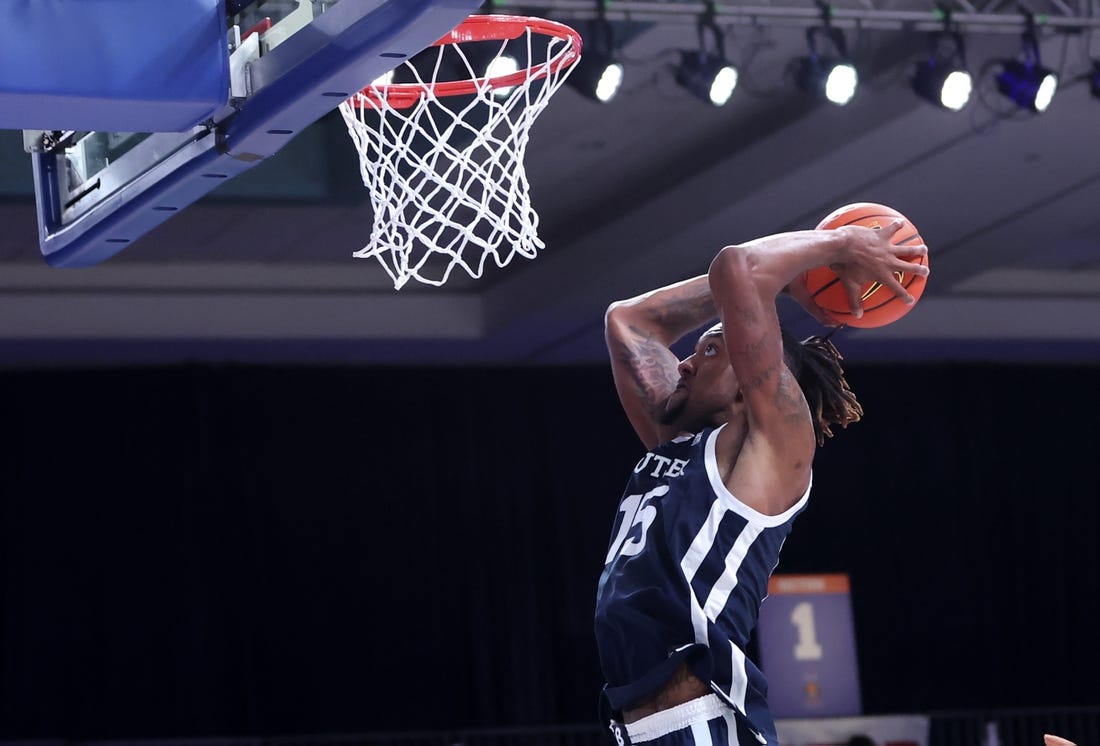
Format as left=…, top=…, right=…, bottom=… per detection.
left=0, top=365, right=1100, bottom=738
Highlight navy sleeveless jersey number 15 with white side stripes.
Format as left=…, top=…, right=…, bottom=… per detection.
left=596, top=426, right=810, bottom=733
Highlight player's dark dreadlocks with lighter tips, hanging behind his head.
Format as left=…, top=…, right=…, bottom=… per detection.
left=783, top=330, right=864, bottom=446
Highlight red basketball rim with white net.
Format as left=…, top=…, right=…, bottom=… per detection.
left=340, top=15, right=581, bottom=289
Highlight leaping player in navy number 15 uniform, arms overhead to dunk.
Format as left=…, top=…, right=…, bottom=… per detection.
left=595, top=222, right=927, bottom=746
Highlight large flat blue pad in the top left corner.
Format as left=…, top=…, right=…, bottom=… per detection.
left=0, top=0, right=229, bottom=132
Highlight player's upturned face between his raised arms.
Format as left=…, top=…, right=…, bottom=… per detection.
left=661, top=330, right=738, bottom=431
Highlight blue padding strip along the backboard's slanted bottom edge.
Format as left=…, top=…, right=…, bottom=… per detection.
left=36, top=0, right=482, bottom=267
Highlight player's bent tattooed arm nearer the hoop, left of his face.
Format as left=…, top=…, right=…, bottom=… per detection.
left=604, top=275, right=716, bottom=448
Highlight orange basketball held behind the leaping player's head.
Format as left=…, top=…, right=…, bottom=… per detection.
left=801, top=202, right=928, bottom=329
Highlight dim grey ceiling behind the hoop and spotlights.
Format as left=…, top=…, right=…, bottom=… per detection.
left=0, top=0, right=1100, bottom=365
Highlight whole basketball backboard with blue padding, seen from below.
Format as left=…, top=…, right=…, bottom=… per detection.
left=0, top=0, right=482, bottom=266
